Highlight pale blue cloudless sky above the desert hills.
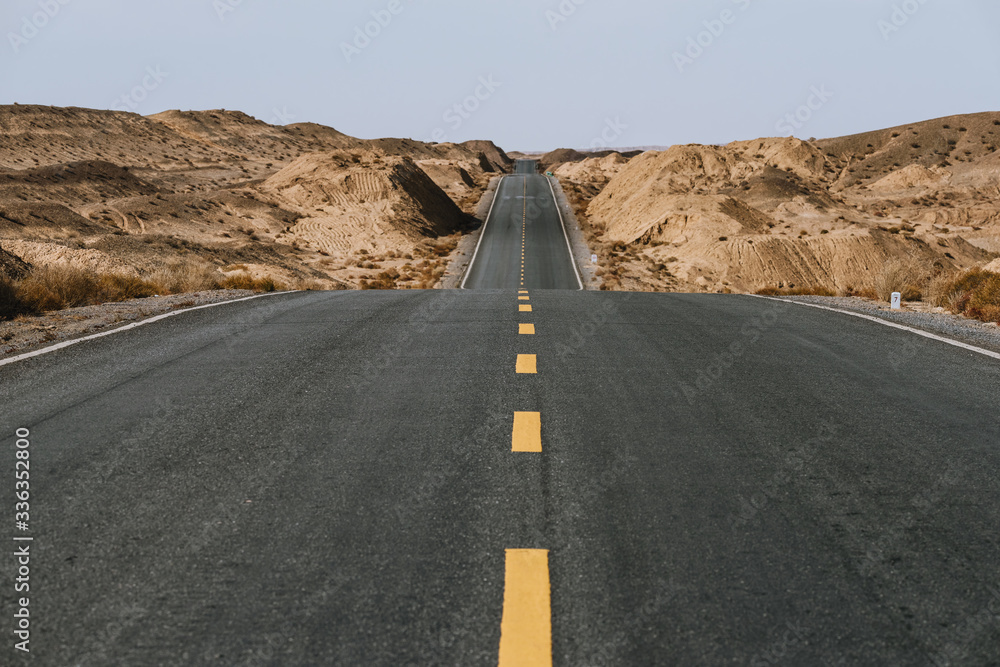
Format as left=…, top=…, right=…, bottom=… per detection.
left=0, top=0, right=1000, bottom=150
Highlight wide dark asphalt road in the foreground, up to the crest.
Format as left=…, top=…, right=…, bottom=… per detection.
left=0, top=290, right=1000, bottom=665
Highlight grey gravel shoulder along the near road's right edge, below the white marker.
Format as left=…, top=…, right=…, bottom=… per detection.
left=785, top=296, right=1000, bottom=352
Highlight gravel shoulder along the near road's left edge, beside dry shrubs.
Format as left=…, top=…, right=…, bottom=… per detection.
left=0, top=290, right=264, bottom=359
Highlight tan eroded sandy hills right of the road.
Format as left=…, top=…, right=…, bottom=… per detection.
left=559, top=114, right=1000, bottom=291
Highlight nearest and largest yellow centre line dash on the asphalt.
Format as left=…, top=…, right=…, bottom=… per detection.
left=499, top=549, right=552, bottom=667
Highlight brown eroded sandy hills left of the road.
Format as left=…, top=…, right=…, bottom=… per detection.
left=0, top=105, right=511, bottom=286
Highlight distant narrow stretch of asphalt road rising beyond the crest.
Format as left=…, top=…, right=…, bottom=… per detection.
left=463, top=160, right=582, bottom=289
